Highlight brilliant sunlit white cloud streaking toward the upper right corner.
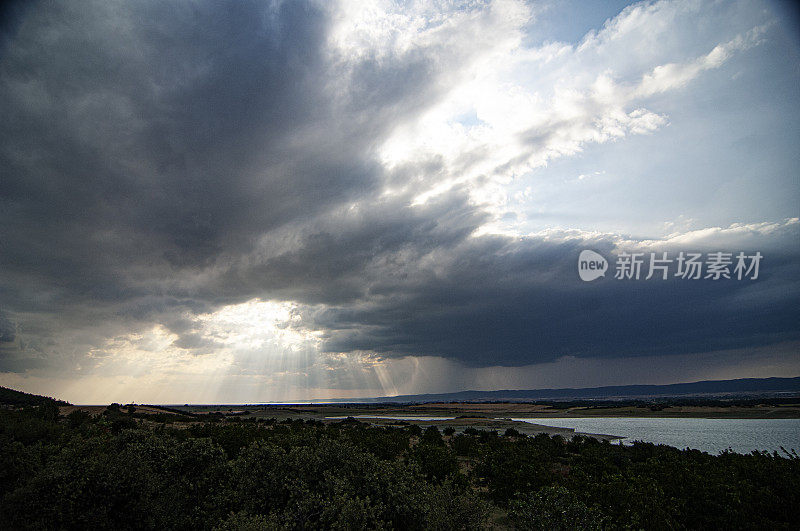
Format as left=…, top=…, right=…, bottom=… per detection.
left=368, top=1, right=769, bottom=231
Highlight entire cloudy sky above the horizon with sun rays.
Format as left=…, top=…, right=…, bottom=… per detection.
left=0, top=0, right=800, bottom=404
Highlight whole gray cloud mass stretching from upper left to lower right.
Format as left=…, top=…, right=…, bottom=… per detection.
left=0, top=2, right=800, bottom=386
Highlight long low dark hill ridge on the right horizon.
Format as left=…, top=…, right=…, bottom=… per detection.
left=324, top=377, right=800, bottom=403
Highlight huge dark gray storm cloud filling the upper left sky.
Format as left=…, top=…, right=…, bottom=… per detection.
left=0, top=2, right=450, bottom=344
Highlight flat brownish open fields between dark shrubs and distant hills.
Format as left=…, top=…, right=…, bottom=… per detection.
left=60, top=401, right=800, bottom=450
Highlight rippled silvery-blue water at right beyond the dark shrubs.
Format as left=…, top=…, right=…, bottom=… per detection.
left=513, top=417, right=800, bottom=454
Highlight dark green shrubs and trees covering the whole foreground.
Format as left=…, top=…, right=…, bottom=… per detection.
left=0, top=401, right=800, bottom=530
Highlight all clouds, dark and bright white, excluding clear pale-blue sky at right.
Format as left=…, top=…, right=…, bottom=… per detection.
left=0, top=2, right=800, bottom=387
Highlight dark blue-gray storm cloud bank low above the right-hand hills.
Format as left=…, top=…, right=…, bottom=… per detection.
left=302, top=230, right=800, bottom=366
